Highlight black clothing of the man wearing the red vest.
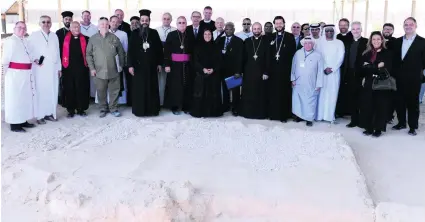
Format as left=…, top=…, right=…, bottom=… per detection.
left=61, top=36, right=90, bottom=112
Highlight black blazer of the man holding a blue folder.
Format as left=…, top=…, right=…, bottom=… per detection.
left=217, top=35, right=243, bottom=78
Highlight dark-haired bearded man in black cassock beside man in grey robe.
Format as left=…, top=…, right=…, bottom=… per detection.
left=267, top=16, right=297, bottom=122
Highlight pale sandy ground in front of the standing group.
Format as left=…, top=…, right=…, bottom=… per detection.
left=2, top=103, right=425, bottom=222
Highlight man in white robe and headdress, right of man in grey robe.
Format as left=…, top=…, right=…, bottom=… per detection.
left=316, top=25, right=345, bottom=123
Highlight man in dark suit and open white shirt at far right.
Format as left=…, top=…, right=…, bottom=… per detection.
left=393, top=17, right=425, bottom=136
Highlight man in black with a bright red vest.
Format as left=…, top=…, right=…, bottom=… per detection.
left=61, top=21, right=90, bottom=118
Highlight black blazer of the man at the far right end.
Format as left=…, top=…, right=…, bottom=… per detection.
left=393, top=35, right=425, bottom=86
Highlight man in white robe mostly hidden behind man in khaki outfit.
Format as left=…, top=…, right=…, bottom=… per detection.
left=96, top=15, right=128, bottom=105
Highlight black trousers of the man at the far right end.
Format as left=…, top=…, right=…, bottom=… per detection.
left=396, top=85, right=420, bottom=129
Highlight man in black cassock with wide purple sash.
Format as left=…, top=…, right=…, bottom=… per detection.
left=164, top=16, right=194, bottom=115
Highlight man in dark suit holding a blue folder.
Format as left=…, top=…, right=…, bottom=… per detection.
left=217, top=19, right=243, bottom=116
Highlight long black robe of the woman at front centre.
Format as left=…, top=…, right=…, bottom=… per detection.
left=190, top=40, right=223, bottom=117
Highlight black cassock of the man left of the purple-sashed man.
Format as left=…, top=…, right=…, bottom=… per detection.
left=127, top=28, right=163, bottom=116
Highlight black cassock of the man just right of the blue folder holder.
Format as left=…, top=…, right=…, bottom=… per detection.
left=240, top=36, right=270, bottom=119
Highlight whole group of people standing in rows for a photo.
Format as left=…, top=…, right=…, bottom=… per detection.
left=2, top=6, right=425, bottom=137
